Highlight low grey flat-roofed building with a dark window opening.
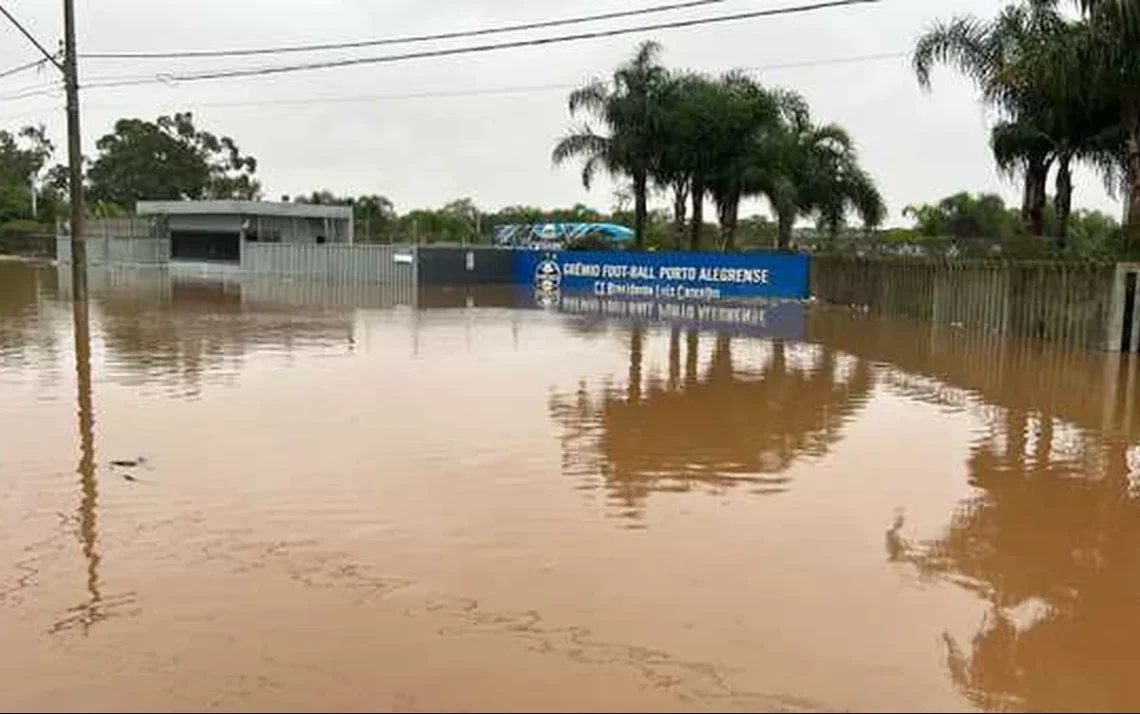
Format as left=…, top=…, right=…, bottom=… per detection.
left=137, top=201, right=352, bottom=263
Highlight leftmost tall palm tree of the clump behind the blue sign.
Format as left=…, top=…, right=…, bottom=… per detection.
left=553, top=42, right=668, bottom=249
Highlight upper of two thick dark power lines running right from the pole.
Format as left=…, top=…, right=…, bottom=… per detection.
left=82, top=0, right=770, bottom=59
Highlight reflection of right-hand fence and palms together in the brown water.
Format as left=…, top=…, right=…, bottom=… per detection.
left=866, top=327, right=1140, bottom=711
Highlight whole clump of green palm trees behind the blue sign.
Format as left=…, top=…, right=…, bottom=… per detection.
left=553, top=43, right=886, bottom=250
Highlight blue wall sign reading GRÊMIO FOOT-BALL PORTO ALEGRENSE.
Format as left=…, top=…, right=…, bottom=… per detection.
left=514, top=251, right=808, bottom=301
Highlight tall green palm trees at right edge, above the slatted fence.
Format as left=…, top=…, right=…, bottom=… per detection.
left=914, top=0, right=1140, bottom=244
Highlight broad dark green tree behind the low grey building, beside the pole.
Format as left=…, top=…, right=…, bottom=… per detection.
left=88, top=112, right=261, bottom=206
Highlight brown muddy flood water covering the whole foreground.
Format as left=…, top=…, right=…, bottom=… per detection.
left=0, top=263, right=1140, bottom=711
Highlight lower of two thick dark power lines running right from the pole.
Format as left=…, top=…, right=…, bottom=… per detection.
left=88, top=0, right=881, bottom=88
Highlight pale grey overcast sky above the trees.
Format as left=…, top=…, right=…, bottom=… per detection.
left=0, top=0, right=1121, bottom=225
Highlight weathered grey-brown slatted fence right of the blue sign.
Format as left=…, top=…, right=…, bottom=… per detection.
left=811, top=255, right=1121, bottom=351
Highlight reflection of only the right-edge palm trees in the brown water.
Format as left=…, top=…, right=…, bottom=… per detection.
left=888, top=376, right=1140, bottom=711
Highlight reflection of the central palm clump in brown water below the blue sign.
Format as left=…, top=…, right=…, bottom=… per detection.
left=549, top=325, right=873, bottom=519
